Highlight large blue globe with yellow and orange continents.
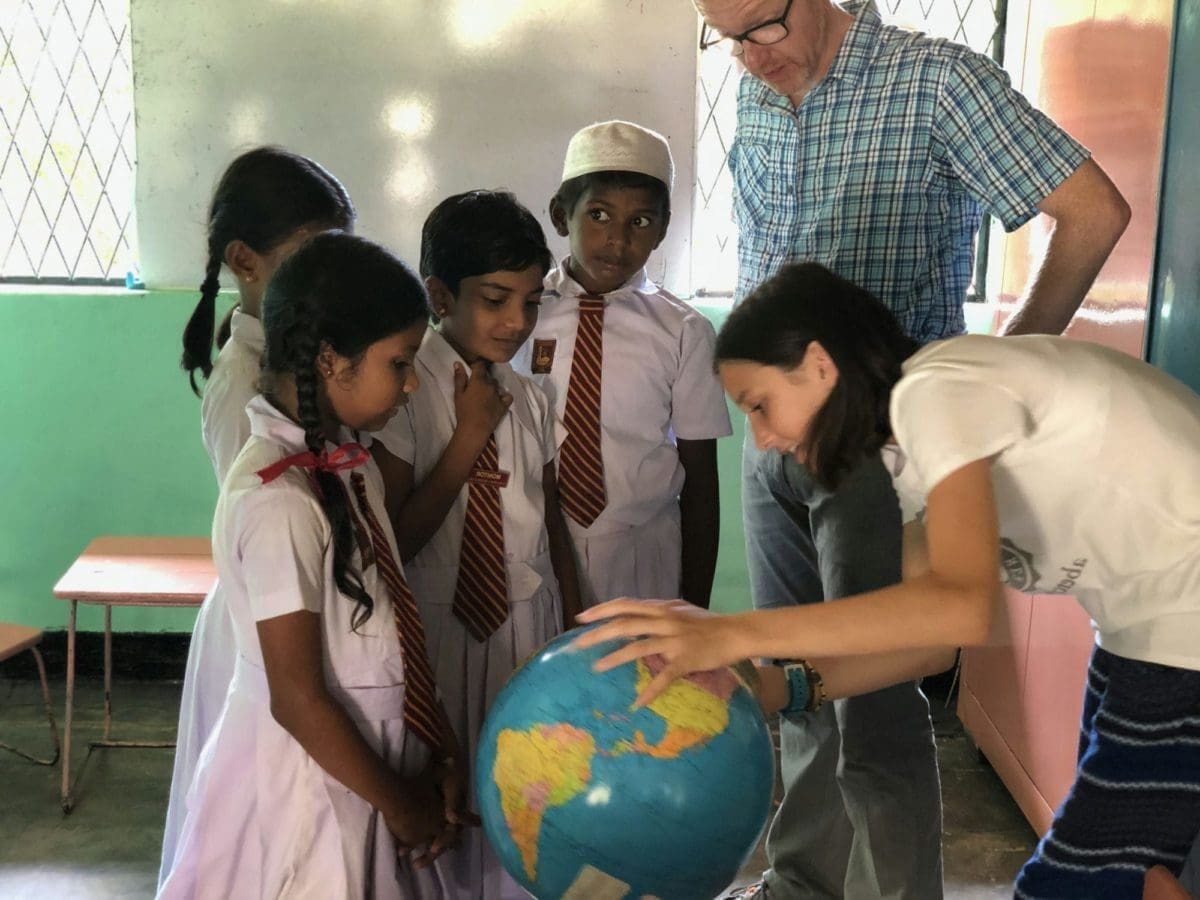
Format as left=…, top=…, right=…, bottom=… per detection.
left=475, top=629, right=774, bottom=900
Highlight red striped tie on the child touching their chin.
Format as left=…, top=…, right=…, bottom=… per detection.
left=451, top=434, right=509, bottom=642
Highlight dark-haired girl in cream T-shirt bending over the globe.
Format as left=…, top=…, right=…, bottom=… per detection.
left=578, top=263, right=1200, bottom=898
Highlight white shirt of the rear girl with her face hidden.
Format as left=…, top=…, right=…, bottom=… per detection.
left=200, top=310, right=266, bottom=485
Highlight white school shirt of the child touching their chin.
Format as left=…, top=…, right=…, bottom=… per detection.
left=372, top=328, right=566, bottom=602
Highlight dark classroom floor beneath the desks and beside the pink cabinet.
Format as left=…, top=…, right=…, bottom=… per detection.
left=0, top=679, right=1034, bottom=900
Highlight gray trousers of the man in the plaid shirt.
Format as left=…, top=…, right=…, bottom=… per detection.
left=742, top=433, right=942, bottom=900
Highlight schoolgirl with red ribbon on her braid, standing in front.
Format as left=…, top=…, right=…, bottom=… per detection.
left=158, top=232, right=463, bottom=899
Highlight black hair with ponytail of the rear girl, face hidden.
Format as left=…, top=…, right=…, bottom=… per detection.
left=180, top=146, right=355, bottom=396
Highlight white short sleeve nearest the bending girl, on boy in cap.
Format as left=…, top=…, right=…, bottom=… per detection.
left=671, top=312, right=733, bottom=440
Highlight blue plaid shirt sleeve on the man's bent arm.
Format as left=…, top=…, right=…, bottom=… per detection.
left=934, top=53, right=1090, bottom=232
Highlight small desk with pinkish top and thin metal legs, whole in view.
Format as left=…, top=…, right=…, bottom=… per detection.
left=54, top=538, right=217, bottom=812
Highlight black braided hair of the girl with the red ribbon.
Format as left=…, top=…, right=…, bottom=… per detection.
left=263, top=232, right=427, bottom=628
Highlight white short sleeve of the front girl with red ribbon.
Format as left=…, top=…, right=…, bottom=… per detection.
left=238, top=489, right=330, bottom=622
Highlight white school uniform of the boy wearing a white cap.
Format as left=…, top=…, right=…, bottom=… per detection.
left=512, top=258, right=733, bottom=606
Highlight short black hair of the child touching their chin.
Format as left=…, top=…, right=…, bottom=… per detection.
left=421, top=191, right=554, bottom=296
